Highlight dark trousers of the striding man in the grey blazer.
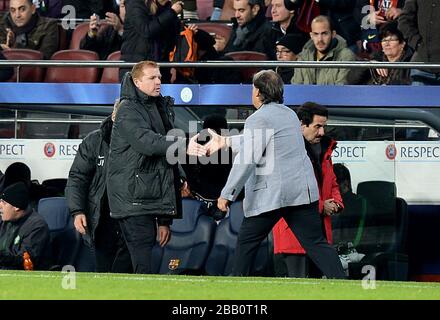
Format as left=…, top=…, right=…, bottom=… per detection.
left=232, top=201, right=345, bottom=279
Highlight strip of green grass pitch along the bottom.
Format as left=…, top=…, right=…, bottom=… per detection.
left=0, top=271, right=440, bottom=300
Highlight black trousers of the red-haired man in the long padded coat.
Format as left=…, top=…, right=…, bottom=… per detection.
left=118, top=215, right=157, bottom=273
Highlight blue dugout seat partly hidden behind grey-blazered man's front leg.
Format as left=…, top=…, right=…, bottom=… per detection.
left=205, top=201, right=273, bottom=276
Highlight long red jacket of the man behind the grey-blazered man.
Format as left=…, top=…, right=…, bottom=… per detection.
left=272, top=138, right=344, bottom=254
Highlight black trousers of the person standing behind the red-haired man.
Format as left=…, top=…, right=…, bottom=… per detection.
left=95, top=213, right=133, bottom=273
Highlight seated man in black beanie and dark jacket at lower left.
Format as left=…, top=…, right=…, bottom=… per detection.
left=0, top=182, right=50, bottom=270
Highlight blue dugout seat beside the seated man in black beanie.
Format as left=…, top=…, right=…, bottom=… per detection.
left=38, top=197, right=82, bottom=270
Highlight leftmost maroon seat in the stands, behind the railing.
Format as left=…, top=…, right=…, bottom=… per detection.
left=3, top=49, right=44, bottom=82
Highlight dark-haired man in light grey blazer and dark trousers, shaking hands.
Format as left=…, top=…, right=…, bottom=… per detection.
left=206, top=70, right=345, bottom=278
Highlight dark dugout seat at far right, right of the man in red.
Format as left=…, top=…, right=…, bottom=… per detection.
left=349, top=181, right=408, bottom=281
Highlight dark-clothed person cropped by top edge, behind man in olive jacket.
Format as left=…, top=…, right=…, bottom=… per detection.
left=314, top=0, right=362, bottom=53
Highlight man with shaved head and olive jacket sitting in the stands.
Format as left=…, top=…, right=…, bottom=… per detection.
left=292, top=16, right=355, bottom=85
